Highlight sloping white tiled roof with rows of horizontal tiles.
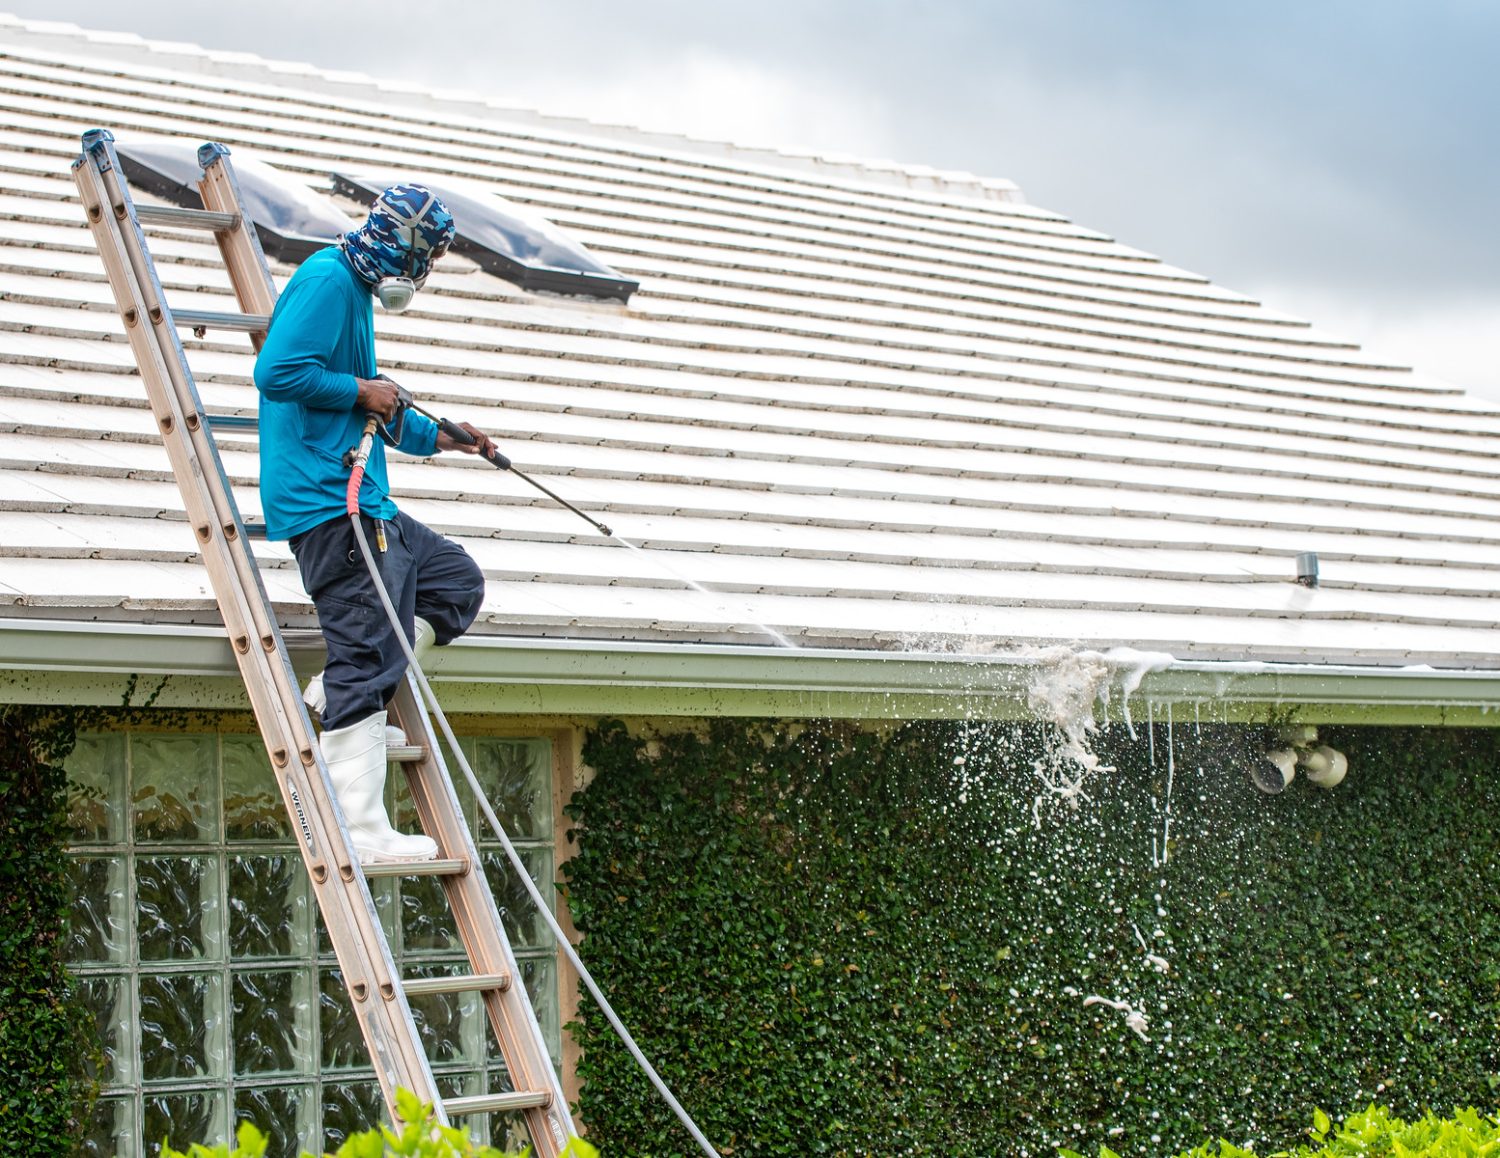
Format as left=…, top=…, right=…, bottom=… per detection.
left=0, top=21, right=1500, bottom=668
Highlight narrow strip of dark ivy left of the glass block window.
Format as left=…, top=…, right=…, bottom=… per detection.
left=0, top=705, right=98, bottom=1158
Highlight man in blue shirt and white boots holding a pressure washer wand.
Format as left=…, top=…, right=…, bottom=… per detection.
left=255, top=185, right=495, bottom=864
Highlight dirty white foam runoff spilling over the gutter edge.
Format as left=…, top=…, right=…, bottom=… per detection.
left=1019, top=647, right=1173, bottom=827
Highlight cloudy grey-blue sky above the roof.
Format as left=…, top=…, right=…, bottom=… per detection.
left=0, top=0, right=1500, bottom=398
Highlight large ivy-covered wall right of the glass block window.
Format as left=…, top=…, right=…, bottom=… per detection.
left=569, top=722, right=1500, bottom=1155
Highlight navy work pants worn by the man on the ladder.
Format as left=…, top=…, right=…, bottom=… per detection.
left=291, top=515, right=485, bottom=729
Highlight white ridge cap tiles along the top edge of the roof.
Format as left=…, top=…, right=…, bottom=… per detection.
left=0, top=12, right=1026, bottom=204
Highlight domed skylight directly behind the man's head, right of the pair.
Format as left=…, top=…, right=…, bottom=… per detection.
left=333, top=173, right=641, bottom=302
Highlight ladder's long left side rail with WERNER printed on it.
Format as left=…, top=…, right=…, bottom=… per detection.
left=74, top=138, right=438, bottom=1122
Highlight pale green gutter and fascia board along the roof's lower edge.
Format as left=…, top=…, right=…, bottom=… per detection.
left=0, top=618, right=1500, bottom=726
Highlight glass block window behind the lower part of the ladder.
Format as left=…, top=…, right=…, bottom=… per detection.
left=68, top=732, right=561, bottom=1158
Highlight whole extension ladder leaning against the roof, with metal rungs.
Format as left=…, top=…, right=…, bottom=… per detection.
left=74, top=129, right=575, bottom=1158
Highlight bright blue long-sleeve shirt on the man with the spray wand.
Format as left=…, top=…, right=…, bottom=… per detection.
left=255, top=246, right=438, bottom=539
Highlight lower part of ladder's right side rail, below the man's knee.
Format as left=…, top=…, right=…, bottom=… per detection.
left=392, top=672, right=575, bottom=1158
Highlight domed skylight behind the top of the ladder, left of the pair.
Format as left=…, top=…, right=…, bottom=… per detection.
left=114, top=141, right=354, bottom=263
